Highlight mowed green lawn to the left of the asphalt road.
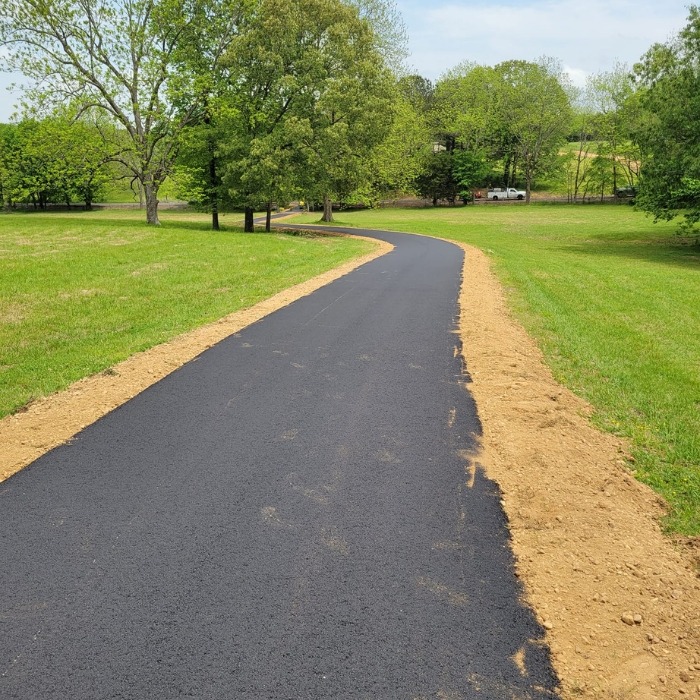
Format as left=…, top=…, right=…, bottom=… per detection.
left=0, top=210, right=372, bottom=416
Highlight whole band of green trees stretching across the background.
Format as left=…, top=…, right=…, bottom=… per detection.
left=0, top=0, right=700, bottom=230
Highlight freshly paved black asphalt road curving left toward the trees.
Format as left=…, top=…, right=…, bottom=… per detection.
left=0, top=229, right=556, bottom=700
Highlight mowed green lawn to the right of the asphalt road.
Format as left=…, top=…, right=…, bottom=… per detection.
left=290, top=204, right=700, bottom=535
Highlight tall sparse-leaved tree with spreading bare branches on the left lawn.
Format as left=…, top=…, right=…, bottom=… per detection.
left=0, top=0, right=246, bottom=224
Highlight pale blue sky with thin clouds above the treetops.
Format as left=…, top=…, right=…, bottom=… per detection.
left=0, top=0, right=690, bottom=121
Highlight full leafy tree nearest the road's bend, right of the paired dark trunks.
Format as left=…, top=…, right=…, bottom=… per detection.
left=264, top=0, right=395, bottom=221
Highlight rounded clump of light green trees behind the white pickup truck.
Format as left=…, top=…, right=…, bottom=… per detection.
left=410, top=58, right=573, bottom=202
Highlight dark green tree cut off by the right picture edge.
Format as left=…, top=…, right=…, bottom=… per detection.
left=634, top=6, right=700, bottom=230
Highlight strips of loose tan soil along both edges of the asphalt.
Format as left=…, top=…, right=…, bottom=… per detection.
left=0, top=234, right=700, bottom=700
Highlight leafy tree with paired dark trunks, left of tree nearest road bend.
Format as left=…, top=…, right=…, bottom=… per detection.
left=217, top=0, right=320, bottom=232
